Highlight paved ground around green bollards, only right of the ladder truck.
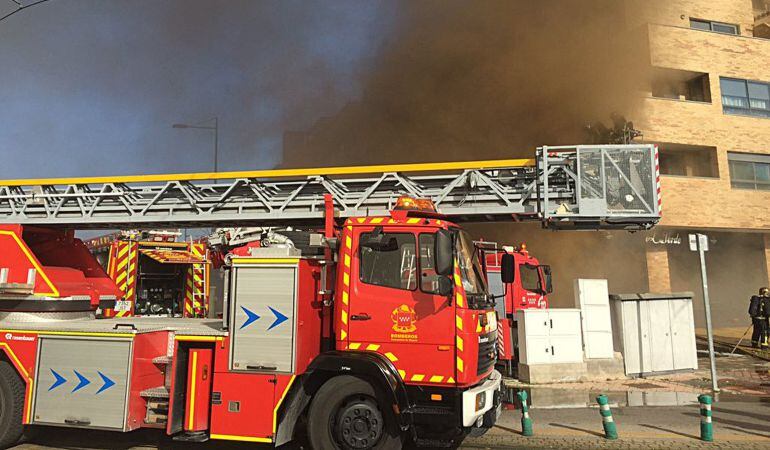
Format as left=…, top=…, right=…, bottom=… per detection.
left=462, top=401, right=770, bottom=449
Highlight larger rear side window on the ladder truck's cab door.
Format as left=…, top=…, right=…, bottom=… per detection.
left=360, top=233, right=417, bottom=291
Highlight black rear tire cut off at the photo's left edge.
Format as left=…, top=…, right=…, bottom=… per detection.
left=0, top=361, right=25, bottom=448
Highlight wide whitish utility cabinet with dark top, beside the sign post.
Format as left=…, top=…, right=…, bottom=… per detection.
left=610, top=292, right=698, bottom=375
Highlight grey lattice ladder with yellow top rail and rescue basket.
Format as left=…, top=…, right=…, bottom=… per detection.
left=0, top=145, right=660, bottom=229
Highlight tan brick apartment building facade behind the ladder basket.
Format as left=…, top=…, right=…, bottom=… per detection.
left=627, top=0, right=770, bottom=326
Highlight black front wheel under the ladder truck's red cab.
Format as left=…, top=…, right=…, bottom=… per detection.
left=307, top=375, right=403, bottom=450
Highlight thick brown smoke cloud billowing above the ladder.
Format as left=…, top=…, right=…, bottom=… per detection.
left=283, top=0, right=643, bottom=167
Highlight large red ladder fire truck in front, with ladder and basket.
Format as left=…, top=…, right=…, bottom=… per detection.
left=0, top=146, right=659, bottom=450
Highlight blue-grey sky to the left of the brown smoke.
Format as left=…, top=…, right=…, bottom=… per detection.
left=0, top=0, right=396, bottom=179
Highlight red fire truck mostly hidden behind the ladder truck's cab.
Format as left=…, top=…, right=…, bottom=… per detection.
left=485, top=243, right=553, bottom=376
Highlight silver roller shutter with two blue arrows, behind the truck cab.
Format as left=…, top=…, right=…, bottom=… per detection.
left=230, top=266, right=297, bottom=373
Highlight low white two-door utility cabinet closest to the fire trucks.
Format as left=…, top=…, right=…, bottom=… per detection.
left=517, top=309, right=583, bottom=365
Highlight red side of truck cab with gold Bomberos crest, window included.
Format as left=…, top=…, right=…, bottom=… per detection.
left=343, top=227, right=454, bottom=382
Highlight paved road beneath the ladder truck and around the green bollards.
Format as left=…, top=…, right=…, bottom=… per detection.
left=16, top=401, right=770, bottom=450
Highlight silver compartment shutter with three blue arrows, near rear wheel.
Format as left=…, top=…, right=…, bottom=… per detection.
left=33, top=337, right=131, bottom=430
